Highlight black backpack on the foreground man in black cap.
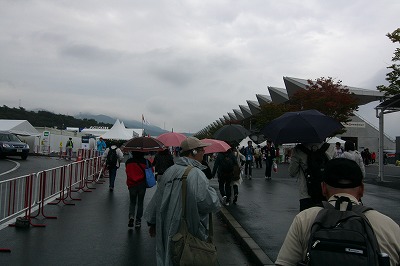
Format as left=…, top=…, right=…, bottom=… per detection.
left=298, top=197, right=390, bottom=266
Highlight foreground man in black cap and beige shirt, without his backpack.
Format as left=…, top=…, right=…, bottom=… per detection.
left=275, top=158, right=400, bottom=265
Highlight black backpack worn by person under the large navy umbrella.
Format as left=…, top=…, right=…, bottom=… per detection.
left=297, top=143, right=329, bottom=203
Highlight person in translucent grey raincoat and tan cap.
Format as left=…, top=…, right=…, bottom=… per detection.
left=144, top=137, right=221, bottom=266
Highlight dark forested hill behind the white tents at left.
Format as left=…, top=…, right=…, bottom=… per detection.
left=0, top=105, right=113, bottom=129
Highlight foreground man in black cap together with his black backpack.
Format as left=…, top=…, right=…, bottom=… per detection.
left=275, top=158, right=400, bottom=266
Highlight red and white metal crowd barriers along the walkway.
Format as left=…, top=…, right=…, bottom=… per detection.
left=0, top=154, right=103, bottom=252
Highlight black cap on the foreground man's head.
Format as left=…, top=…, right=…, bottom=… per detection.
left=322, top=158, right=363, bottom=188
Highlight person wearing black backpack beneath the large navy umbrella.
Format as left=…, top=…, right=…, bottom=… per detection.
left=289, top=143, right=330, bottom=211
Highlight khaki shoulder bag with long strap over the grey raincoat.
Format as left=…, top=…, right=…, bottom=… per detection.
left=170, top=166, right=217, bottom=266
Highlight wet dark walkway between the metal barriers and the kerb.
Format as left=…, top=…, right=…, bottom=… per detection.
left=0, top=166, right=254, bottom=266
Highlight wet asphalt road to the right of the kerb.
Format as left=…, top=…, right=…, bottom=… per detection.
left=216, top=164, right=400, bottom=261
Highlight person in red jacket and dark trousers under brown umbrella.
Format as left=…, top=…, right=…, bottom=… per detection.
left=125, top=151, right=151, bottom=228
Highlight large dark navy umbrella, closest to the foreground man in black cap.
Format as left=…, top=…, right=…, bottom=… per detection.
left=261, top=110, right=343, bottom=144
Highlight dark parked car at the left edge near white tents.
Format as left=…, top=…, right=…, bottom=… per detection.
left=0, top=132, right=29, bottom=160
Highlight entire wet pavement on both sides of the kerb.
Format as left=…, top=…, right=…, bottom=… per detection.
left=0, top=159, right=400, bottom=266
